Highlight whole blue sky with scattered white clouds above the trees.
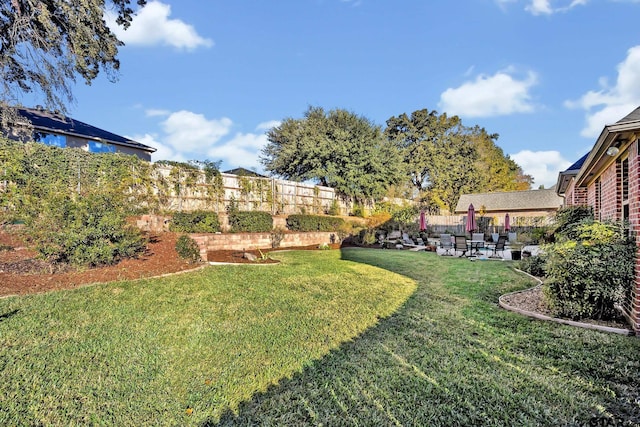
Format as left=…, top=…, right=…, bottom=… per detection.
left=42, top=0, right=640, bottom=188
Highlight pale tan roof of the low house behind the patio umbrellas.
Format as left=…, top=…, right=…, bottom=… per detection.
left=456, top=188, right=563, bottom=213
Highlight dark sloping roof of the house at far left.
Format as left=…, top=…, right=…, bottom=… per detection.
left=17, top=108, right=156, bottom=153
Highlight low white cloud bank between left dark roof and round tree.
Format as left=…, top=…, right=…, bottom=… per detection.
left=132, top=109, right=280, bottom=169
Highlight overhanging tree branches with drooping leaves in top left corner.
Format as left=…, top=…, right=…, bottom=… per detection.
left=0, top=0, right=146, bottom=119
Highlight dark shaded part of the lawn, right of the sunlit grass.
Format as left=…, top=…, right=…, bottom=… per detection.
left=201, top=250, right=640, bottom=426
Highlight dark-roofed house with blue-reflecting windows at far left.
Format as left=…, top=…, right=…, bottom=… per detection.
left=7, top=108, right=156, bottom=161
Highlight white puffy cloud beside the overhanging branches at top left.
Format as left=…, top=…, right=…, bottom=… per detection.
left=105, top=1, right=213, bottom=50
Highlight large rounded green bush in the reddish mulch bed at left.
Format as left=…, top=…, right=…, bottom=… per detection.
left=27, top=194, right=145, bottom=267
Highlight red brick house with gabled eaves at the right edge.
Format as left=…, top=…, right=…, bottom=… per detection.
left=557, top=108, right=640, bottom=332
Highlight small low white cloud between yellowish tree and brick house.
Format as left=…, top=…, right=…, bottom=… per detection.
left=509, top=150, right=572, bottom=188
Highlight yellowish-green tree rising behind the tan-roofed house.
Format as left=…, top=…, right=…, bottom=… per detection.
left=385, top=109, right=531, bottom=211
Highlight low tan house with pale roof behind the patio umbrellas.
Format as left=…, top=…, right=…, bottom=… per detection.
left=455, top=188, right=563, bottom=226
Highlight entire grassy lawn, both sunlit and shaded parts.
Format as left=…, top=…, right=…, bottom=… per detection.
left=0, top=249, right=640, bottom=426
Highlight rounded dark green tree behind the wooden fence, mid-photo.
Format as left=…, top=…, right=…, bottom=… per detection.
left=261, top=107, right=403, bottom=202
